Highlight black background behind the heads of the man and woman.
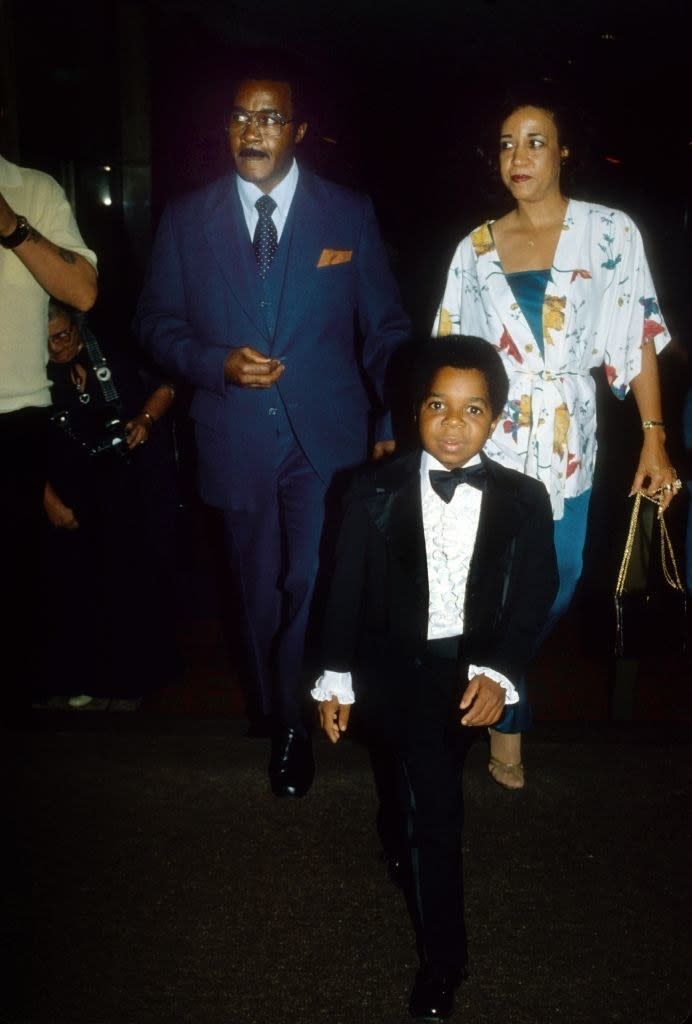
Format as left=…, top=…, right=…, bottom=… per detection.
left=0, top=0, right=692, bottom=598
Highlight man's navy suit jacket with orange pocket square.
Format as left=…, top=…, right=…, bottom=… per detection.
left=136, top=170, right=409, bottom=508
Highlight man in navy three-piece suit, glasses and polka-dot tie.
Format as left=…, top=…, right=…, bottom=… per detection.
left=137, top=58, right=409, bottom=797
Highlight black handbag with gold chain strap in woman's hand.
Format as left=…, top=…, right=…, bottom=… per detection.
left=615, top=492, right=687, bottom=657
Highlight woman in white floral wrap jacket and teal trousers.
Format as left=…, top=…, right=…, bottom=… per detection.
left=433, top=88, right=680, bottom=788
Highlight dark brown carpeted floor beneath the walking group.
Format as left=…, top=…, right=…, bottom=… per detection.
left=9, top=512, right=692, bottom=1024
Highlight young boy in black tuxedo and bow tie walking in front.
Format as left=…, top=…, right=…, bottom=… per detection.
left=312, top=336, right=557, bottom=1021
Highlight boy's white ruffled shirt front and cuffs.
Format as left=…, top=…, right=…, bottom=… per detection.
left=310, top=452, right=519, bottom=705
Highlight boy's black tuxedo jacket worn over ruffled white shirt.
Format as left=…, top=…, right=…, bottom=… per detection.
left=321, top=452, right=558, bottom=729
